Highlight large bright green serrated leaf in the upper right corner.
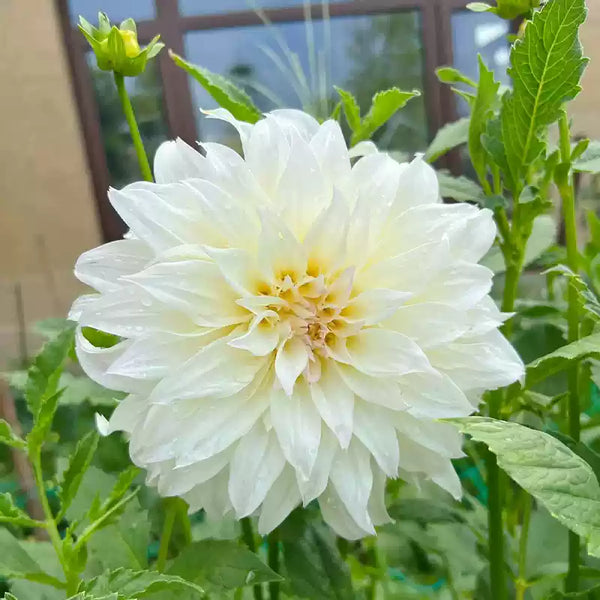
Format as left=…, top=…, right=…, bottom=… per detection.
left=484, top=0, right=586, bottom=191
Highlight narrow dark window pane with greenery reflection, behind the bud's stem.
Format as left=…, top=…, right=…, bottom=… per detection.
left=87, top=52, right=168, bottom=187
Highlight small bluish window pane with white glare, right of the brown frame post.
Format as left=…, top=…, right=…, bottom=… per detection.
left=452, top=10, right=510, bottom=116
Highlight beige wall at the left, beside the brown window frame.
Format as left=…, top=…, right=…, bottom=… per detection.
left=0, top=0, right=100, bottom=370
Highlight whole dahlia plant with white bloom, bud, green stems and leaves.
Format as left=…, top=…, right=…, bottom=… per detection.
left=0, top=0, right=600, bottom=600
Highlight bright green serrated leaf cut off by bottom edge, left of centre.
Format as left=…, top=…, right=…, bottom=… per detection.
left=84, top=569, right=204, bottom=600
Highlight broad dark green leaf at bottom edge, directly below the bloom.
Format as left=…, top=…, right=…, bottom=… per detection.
left=167, top=540, right=281, bottom=590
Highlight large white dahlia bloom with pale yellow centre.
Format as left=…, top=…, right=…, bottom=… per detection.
left=71, top=109, right=523, bottom=538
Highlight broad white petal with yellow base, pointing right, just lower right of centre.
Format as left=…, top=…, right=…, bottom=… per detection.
left=347, top=329, right=431, bottom=377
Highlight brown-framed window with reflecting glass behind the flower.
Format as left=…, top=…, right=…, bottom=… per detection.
left=56, top=0, right=480, bottom=239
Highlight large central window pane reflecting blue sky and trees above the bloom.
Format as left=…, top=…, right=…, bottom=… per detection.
left=186, top=12, right=427, bottom=157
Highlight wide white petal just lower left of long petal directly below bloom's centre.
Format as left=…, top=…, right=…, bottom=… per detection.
left=229, top=424, right=286, bottom=518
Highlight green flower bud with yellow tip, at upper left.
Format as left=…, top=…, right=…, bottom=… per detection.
left=79, top=13, right=164, bottom=77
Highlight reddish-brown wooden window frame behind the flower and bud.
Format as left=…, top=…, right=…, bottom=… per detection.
left=55, top=0, right=467, bottom=241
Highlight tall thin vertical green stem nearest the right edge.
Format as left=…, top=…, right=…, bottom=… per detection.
left=557, top=110, right=581, bottom=592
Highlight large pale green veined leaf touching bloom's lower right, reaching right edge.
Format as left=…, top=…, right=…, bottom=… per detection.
left=448, top=417, right=600, bottom=557
